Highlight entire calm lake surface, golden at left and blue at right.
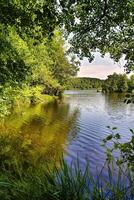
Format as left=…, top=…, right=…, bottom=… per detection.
left=0, top=90, right=134, bottom=178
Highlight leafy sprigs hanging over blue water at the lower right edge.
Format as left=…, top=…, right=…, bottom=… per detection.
left=103, top=126, right=134, bottom=172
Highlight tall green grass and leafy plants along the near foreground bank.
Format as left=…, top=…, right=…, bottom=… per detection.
left=0, top=128, right=134, bottom=200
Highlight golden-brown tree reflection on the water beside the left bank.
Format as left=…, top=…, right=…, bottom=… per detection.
left=0, top=102, right=78, bottom=171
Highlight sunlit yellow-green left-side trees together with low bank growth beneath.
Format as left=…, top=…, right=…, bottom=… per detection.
left=0, top=25, right=76, bottom=116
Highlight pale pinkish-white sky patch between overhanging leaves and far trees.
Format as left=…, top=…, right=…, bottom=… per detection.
left=77, top=53, right=124, bottom=79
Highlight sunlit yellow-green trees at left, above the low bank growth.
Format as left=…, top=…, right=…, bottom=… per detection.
left=0, top=27, right=77, bottom=85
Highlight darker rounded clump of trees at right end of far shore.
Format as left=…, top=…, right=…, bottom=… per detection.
left=102, top=73, right=134, bottom=92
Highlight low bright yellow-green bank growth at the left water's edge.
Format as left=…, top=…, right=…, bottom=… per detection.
left=0, top=85, right=58, bottom=119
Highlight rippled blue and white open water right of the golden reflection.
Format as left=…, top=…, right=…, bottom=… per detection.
left=63, top=90, right=134, bottom=174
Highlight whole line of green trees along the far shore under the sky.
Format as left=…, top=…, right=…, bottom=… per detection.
left=66, top=73, right=134, bottom=92
